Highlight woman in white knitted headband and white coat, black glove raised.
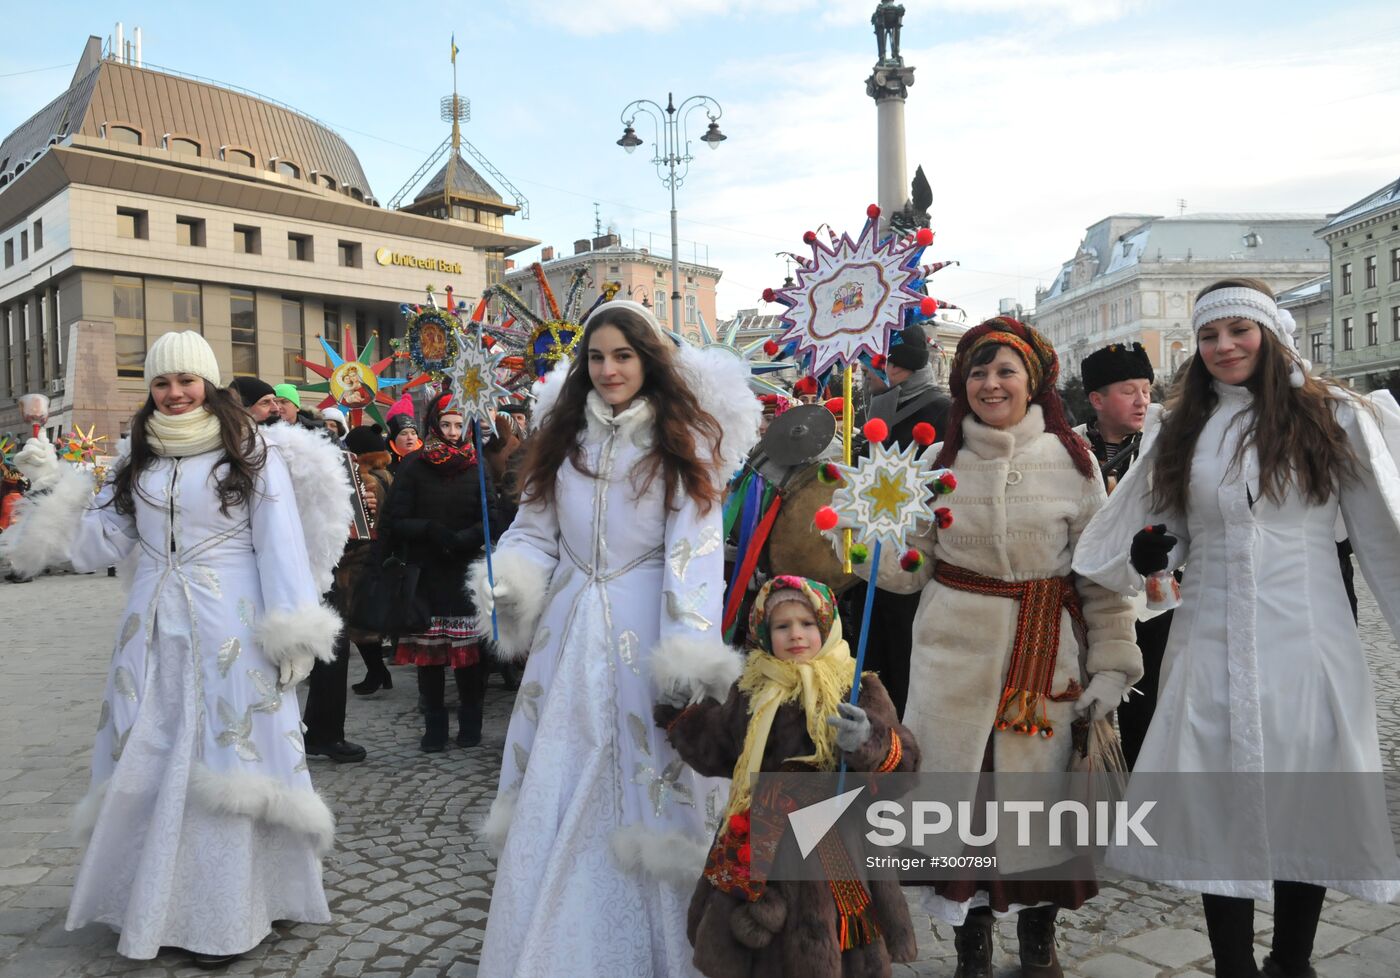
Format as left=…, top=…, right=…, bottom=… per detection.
left=1074, top=278, right=1400, bottom=978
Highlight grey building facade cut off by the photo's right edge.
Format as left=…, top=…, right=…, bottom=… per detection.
left=1317, top=180, right=1400, bottom=390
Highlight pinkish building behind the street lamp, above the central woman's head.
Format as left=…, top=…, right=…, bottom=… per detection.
left=505, top=234, right=724, bottom=341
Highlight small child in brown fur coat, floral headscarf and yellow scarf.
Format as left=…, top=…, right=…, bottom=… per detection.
left=655, top=576, right=918, bottom=978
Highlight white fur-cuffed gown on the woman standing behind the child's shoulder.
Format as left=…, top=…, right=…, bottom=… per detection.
left=480, top=394, right=728, bottom=978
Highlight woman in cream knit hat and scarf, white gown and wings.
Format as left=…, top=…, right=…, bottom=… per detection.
left=4, top=332, right=350, bottom=967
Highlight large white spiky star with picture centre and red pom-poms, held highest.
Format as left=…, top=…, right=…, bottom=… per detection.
left=773, top=206, right=924, bottom=376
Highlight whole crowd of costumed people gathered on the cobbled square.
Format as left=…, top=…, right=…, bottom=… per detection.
left=0, top=280, right=1400, bottom=978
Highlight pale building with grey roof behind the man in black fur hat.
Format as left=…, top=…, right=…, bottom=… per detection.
left=1032, top=214, right=1329, bottom=378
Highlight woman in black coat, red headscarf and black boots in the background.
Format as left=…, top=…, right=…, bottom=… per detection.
left=379, top=395, right=497, bottom=753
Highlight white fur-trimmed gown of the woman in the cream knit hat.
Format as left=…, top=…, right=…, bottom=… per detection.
left=67, top=449, right=337, bottom=958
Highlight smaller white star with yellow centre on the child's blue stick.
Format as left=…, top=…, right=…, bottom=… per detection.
left=832, top=442, right=941, bottom=548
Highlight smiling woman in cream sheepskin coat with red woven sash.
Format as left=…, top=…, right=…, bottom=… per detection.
left=857, top=318, right=1142, bottom=978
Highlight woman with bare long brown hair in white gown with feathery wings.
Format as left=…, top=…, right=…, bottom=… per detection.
left=472, top=301, right=760, bottom=978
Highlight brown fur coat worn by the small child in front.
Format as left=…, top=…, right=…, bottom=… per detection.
left=655, top=673, right=918, bottom=978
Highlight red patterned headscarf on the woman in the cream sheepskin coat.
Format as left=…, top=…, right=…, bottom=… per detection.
left=934, top=316, right=1098, bottom=479
